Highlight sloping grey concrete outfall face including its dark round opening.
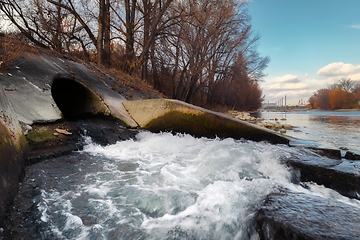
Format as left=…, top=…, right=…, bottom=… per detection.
left=0, top=53, right=137, bottom=127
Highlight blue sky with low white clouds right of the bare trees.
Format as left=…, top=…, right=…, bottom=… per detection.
left=249, top=0, right=360, bottom=104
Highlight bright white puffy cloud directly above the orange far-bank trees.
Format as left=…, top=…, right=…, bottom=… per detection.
left=317, top=62, right=360, bottom=77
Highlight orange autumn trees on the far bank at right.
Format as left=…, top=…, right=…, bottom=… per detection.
left=309, top=79, right=360, bottom=110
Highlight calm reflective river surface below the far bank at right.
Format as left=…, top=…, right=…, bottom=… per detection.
left=260, top=111, right=360, bottom=152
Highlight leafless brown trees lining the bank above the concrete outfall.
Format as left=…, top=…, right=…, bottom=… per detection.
left=0, top=0, right=269, bottom=110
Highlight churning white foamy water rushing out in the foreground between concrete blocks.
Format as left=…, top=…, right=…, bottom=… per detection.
left=33, top=132, right=360, bottom=239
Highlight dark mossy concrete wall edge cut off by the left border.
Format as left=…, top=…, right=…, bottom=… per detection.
left=0, top=85, right=27, bottom=227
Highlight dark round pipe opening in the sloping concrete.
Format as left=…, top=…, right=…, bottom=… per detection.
left=51, top=74, right=110, bottom=119
